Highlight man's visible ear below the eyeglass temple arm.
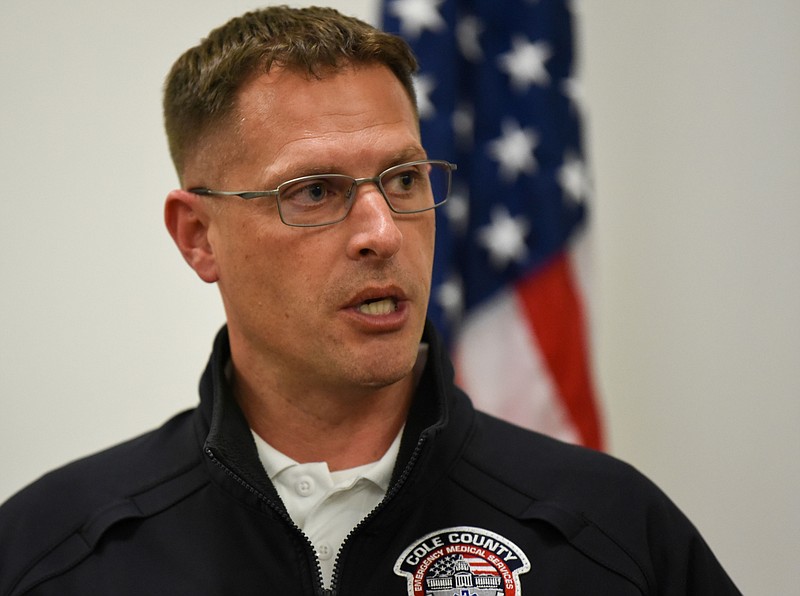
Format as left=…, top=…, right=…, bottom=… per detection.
left=164, top=190, right=219, bottom=283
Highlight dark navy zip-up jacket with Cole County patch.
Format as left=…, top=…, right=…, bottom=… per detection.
left=0, top=327, right=739, bottom=596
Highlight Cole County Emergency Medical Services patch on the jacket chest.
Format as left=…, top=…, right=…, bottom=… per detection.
left=394, top=526, right=531, bottom=596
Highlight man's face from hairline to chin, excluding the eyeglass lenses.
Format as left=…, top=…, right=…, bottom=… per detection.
left=187, top=66, right=435, bottom=391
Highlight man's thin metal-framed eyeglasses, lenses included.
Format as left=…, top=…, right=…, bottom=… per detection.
left=189, top=159, right=457, bottom=227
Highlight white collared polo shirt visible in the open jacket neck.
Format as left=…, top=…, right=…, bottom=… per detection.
left=251, top=429, right=403, bottom=587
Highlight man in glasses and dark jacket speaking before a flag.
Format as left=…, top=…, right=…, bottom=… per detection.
left=0, top=8, right=738, bottom=596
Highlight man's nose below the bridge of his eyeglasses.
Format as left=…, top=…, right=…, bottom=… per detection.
left=346, top=183, right=403, bottom=259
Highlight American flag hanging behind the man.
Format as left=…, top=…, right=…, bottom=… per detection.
left=382, top=0, right=602, bottom=448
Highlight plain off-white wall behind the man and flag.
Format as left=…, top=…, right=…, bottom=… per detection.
left=0, top=0, right=800, bottom=595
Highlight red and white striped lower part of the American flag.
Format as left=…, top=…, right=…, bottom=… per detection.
left=455, top=253, right=603, bottom=449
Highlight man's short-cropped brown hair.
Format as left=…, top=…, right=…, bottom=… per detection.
left=164, top=6, right=417, bottom=177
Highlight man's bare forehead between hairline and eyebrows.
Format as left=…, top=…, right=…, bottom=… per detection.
left=230, top=66, right=422, bottom=175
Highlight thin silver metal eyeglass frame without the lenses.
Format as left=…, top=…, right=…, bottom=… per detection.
left=188, top=159, right=458, bottom=228
